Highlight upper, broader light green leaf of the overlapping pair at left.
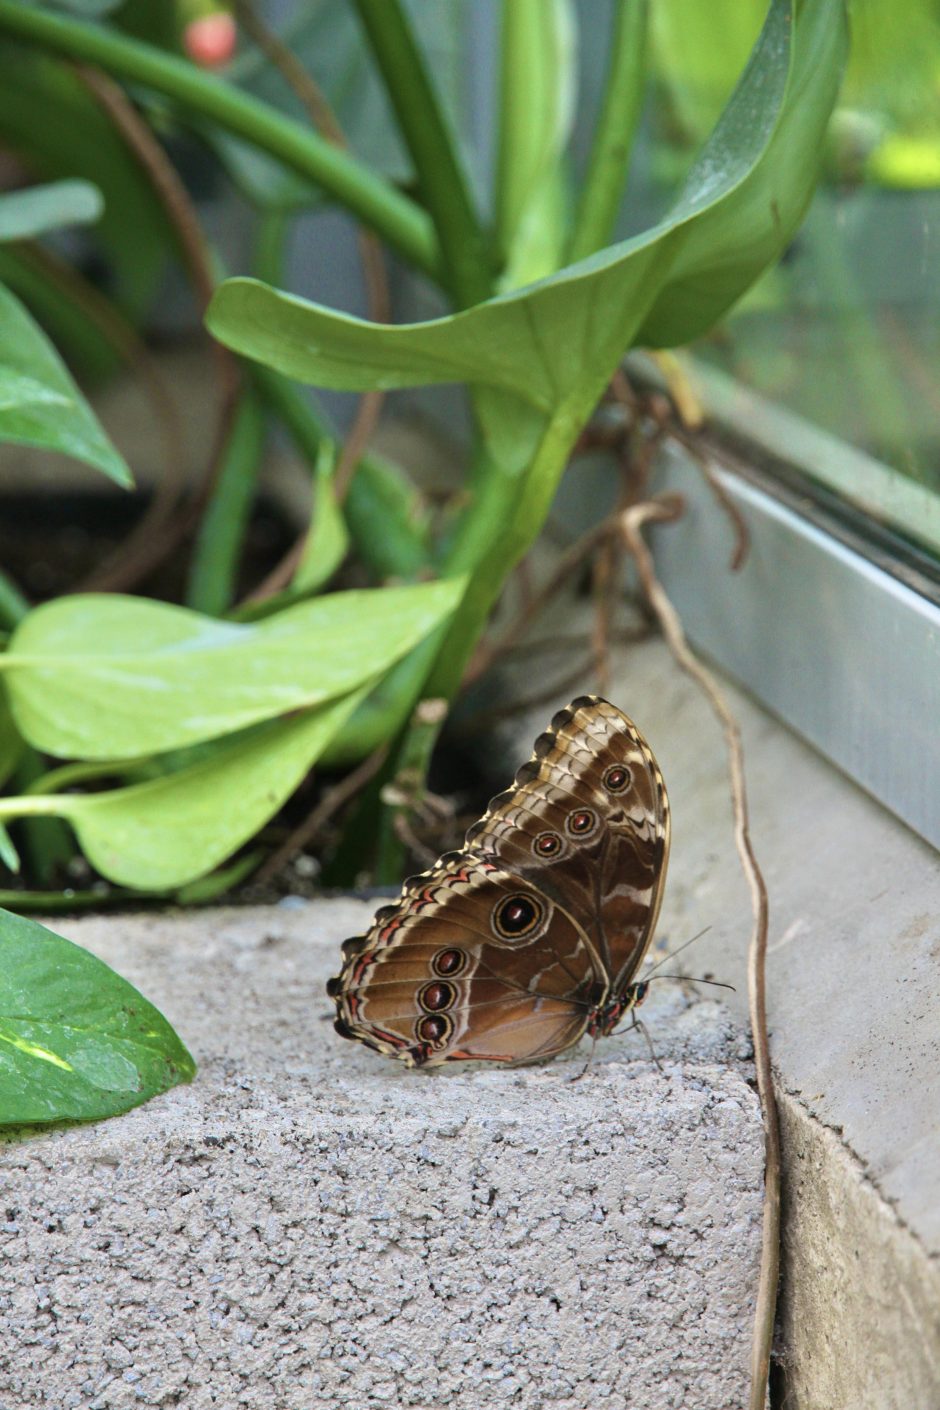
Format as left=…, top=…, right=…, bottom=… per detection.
left=0, top=578, right=464, bottom=759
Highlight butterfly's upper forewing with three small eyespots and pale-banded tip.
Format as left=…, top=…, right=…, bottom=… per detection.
left=466, top=695, right=669, bottom=995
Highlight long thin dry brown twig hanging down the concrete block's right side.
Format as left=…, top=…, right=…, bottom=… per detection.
left=621, top=495, right=781, bottom=1410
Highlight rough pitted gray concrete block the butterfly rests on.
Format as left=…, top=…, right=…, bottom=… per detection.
left=0, top=900, right=762, bottom=1410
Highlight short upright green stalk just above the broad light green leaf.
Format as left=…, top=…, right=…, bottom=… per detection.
left=186, top=391, right=265, bottom=616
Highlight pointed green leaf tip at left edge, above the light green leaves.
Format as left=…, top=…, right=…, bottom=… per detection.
left=0, top=286, right=134, bottom=486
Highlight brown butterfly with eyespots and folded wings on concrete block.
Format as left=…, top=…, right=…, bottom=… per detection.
left=327, top=695, right=669, bottom=1067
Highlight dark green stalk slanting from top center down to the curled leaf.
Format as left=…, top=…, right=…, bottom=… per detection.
left=349, top=0, right=493, bottom=307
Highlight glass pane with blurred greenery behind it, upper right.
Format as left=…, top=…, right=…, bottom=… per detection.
left=633, top=0, right=940, bottom=557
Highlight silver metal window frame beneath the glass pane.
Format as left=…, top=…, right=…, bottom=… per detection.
left=654, top=379, right=940, bottom=847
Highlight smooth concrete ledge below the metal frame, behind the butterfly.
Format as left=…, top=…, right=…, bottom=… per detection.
left=482, top=623, right=940, bottom=1410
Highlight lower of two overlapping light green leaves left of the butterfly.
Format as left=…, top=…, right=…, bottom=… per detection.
left=51, top=689, right=366, bottom=891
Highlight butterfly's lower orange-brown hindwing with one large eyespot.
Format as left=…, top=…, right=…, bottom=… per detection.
left=328, top=849, right=603, bottom=1066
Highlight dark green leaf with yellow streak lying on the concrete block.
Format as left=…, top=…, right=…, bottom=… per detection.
left=0, top=911, right=196, bottom=1125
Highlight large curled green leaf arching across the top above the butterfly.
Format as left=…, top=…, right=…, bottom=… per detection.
left=207, top=0, right=846, bottom=443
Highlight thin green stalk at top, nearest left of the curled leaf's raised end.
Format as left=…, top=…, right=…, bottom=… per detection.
left=568, top=0, right=648, bottom=264
